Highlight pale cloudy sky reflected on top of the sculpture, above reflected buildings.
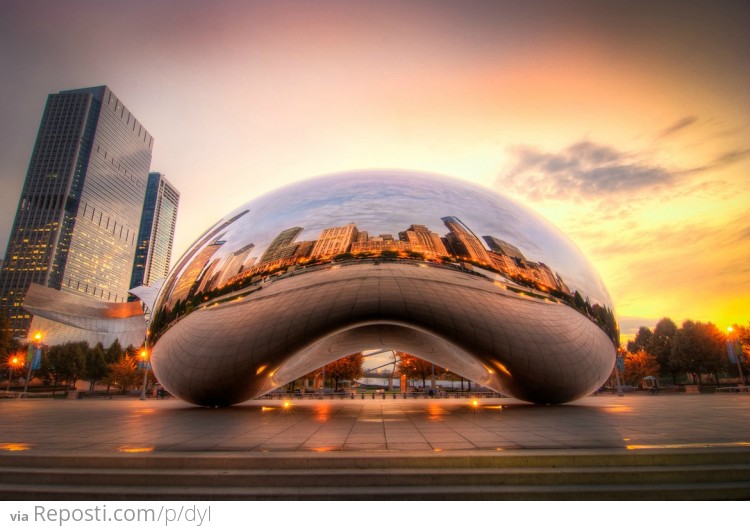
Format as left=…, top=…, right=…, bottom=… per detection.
left=195, top=170, right=612, bottom=306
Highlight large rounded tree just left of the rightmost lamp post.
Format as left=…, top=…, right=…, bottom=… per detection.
left=670, top=320, right=726, bottom=385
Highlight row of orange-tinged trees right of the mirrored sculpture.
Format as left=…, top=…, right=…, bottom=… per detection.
left=622, top=317, right=750, bottom=385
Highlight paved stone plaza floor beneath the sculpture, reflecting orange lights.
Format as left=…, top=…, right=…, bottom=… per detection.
left=0, top=393, right=750, bottom=453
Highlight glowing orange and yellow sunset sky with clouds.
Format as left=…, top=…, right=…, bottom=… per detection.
left=0, top=0, right=750, bottom=338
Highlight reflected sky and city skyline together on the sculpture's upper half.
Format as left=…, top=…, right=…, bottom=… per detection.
left=152, top=173, right=618, bottom=342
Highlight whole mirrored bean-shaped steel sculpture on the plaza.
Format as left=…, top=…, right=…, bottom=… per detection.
left=149, top=171, right=619, bottom=406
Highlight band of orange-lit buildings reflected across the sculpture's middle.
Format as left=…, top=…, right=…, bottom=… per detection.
left=167, top=216, right=571, bottom=309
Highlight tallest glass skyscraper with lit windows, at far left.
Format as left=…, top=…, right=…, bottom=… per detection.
left=0, top=86, right=153, bottom=337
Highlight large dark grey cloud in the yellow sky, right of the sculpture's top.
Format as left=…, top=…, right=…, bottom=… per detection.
left=496, top=141, right=678, bottom=200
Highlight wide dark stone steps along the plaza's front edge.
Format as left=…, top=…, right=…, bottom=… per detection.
left=0, top=448, right=750, bottom=501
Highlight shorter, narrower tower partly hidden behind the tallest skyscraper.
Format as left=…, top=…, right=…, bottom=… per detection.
left=130, top=172, right=180, bottom=289
